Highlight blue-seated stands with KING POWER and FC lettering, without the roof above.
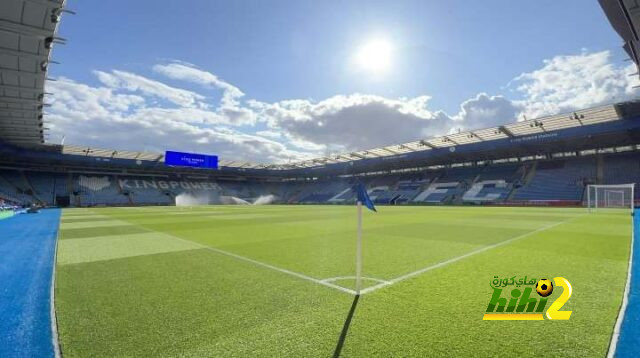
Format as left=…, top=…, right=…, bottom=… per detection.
left=0, top=151, right=640, bottom=206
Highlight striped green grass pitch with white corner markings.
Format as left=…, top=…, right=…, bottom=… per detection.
left=55, top=205, right=631, bottom=357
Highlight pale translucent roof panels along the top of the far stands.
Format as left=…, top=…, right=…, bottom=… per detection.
left=62, top=105, right=621, bottom=170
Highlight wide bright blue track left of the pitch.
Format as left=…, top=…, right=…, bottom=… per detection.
left=0, top=209, right=61, bottom=357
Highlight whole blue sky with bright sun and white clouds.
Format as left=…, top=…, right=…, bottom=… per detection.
left=45, top=0, right=638, bottom=163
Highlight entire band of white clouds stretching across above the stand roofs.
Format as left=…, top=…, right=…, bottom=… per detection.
left=47, top=51, right=637, bottom=162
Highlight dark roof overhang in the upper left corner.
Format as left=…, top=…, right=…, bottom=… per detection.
left=0, top=0, right=65, bottom=145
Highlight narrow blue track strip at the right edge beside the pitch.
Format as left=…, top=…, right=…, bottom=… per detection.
left=616, top=208, right=640, bottom=358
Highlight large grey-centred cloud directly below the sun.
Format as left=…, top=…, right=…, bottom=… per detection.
left=250, top=94, right=447, bottom=151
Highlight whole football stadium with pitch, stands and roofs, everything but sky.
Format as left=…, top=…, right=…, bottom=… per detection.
left=0, top=0, right=640, bottom=357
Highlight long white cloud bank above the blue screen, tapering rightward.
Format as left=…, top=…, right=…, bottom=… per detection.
left=47, top=78, right=309, bottom=162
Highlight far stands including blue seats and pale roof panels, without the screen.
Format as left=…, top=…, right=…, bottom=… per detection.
left=0, top=102, right=640, bottom=206
